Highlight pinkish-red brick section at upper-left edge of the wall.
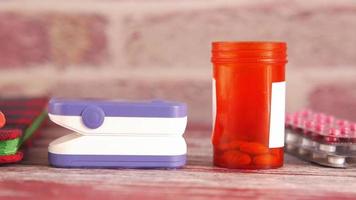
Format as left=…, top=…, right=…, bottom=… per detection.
left=0, top=13, right=50, bottom=68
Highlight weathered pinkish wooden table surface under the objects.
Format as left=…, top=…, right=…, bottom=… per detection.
left=0, top=125, right=356, bottom=200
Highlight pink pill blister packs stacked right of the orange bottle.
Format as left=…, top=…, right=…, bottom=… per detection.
left=285, top=109, right=356, bottom=168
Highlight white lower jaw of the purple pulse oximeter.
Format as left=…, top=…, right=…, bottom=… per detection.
left=48, top=133, right=187, bottom=156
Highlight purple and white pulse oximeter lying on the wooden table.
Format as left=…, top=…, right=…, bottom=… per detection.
left=48, top=99, right=187, bottom=168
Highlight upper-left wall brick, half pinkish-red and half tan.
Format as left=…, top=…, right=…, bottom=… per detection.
left=0, top=12, right=108, bottom=68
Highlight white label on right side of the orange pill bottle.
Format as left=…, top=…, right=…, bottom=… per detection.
left=268, top=82, right=286, bottom=148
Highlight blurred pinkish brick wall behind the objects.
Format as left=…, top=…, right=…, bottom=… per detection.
left=0, top=0, right=356, bottom=124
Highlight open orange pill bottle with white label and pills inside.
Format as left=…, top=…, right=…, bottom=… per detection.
left=211, top=42, right=287, bottom=169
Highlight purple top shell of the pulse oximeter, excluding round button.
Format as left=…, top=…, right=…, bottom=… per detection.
left=48, top=98, right=187, bottom=118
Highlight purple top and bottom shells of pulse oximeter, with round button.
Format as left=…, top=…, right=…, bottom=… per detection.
left=48, top=98, right=187, bottom=168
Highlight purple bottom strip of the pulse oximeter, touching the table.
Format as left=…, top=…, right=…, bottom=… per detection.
left=48, top=153, right=186, bottom=169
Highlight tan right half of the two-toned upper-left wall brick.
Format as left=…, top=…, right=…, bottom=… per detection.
left=47, top=13, right=108, bottom=65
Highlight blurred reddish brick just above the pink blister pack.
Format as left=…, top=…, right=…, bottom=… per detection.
left=309, top=82, right=356, bottom=121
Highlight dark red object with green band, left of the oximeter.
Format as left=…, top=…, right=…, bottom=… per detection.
left=0, top=98, right=47, bottom=164
